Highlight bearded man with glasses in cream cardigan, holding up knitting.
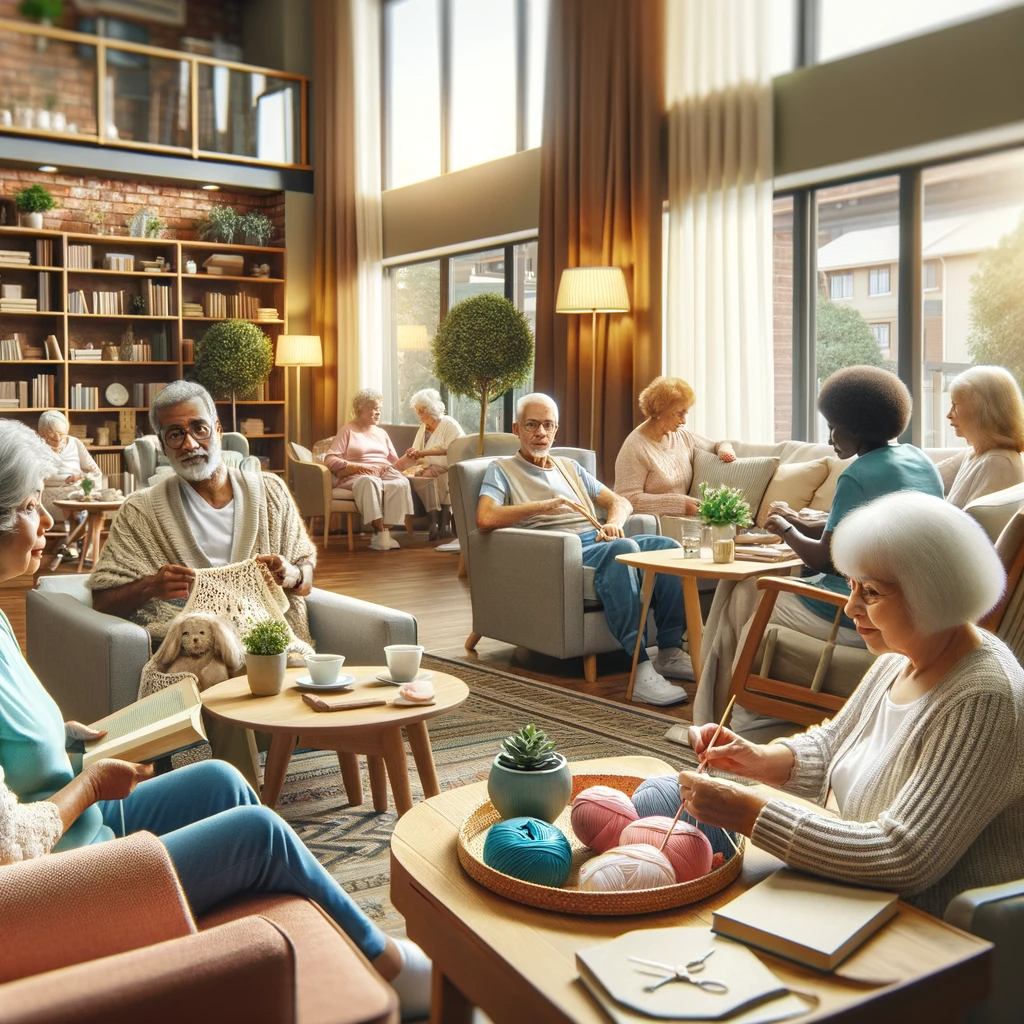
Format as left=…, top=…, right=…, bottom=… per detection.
left=88, top=381, right=316, bottom=642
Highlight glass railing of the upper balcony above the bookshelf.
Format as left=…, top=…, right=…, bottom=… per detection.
left=0, top=18, right=309, bottom=167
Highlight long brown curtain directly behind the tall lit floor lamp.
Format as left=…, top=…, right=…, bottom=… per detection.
left=535, top=0, right=665, bottom=486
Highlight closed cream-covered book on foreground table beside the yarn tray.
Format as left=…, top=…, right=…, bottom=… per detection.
left=713, top=868, right=899, bottom=971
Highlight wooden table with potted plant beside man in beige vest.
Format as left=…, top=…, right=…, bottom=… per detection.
left=615, top=548, right=804, bottom=700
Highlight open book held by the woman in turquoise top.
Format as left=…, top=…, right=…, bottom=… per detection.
left=82, top=679, right=206, bottom=768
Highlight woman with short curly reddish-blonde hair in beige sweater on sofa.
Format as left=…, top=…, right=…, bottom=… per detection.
left=613, top=377, right=736, bottom=515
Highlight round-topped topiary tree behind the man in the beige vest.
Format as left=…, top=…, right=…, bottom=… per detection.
left=433, top=294, right=534, bottom=455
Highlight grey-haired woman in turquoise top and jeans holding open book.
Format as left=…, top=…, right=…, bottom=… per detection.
left=0, top=422, right=430, bottom=1016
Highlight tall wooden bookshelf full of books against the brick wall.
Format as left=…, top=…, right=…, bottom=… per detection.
left=0, top=227, right=288, bottom=473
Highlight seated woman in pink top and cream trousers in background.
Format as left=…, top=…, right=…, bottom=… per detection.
left=324, top=387, right=413, bottom=551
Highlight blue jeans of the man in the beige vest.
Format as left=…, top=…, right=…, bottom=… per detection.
left=580, top=529, right=683, bottom=662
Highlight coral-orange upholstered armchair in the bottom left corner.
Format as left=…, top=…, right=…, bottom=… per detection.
left=0, top=833, right=398, bottom=1024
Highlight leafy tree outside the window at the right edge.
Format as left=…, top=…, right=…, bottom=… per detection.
left=967, top=219, right=1024, bottom=387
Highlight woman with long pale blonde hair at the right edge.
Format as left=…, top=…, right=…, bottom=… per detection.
left=939, top=367, right=1024, bottom=509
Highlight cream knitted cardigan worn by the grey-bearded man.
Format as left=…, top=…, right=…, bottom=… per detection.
left=88, top=467, right=316, bottom=642
